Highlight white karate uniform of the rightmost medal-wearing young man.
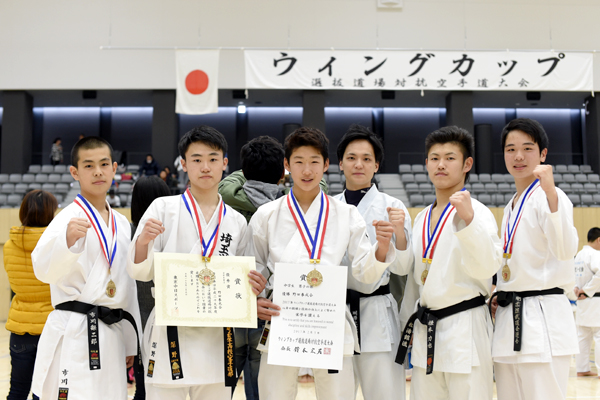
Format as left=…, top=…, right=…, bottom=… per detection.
left=492, top=183, right=579, bottom=400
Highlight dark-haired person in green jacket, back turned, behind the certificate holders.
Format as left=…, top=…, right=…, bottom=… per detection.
left=219, top=136, right=328, bottom=400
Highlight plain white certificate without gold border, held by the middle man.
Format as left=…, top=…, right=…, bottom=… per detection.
left=267, top=263, right=347, bottom=370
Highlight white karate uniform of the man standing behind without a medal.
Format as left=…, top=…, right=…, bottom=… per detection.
left=334, top=185, right=414, bottom=400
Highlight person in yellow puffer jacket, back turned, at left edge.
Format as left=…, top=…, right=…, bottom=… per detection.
left=4, top=190, right=58, bottom=400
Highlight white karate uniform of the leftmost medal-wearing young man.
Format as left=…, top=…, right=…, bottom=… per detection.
left=31, top=203, right=142, bottom=400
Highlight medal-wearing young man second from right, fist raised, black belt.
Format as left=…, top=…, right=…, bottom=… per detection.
left=397, top=126, right=502, bottom=400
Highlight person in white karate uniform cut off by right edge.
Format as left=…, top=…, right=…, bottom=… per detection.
left=575, top=228, right=600, bottom=376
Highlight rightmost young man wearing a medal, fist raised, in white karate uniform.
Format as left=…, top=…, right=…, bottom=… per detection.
left=492, top=118, right=578, bottom=400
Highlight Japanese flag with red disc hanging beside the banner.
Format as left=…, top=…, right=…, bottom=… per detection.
left=175, top=50, right=219, bottom=114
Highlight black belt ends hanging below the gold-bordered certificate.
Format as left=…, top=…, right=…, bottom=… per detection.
left=166, top=326, right=238, bottom=387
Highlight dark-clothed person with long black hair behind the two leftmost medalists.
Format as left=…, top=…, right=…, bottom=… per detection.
left=128, top=176, right=171, bottom=400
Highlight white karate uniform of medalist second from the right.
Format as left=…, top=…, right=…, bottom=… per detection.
left=403, top=199, right=502, bottom=400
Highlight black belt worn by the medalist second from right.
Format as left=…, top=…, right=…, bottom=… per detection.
left=396, top=295, right=485, bottom=375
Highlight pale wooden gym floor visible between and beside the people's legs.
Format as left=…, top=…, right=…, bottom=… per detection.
left=0, top=322, right=600, bottom=400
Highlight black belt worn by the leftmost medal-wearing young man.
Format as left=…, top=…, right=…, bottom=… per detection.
left=54, top=301, right=144, bottom=371
